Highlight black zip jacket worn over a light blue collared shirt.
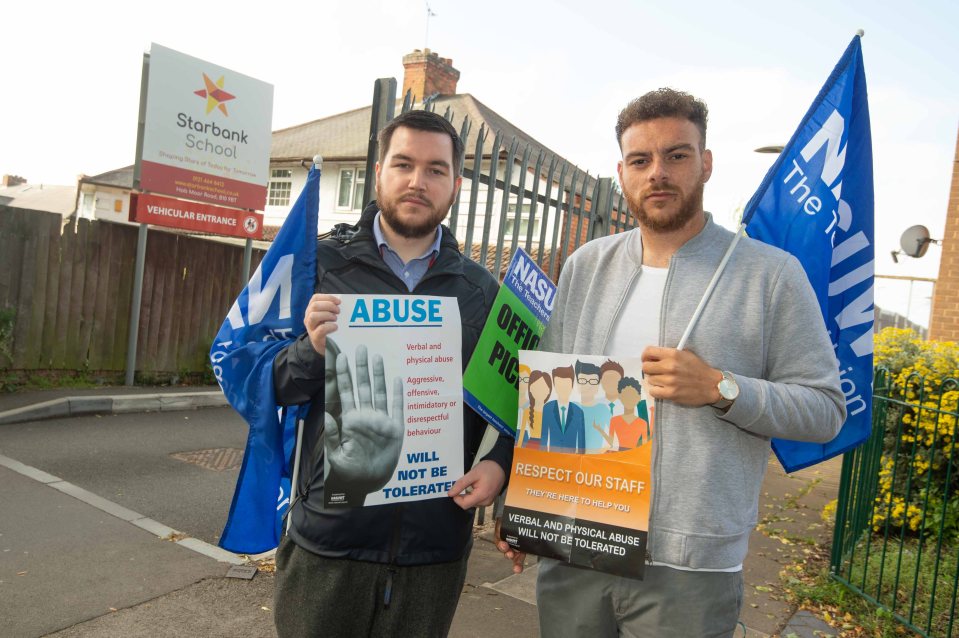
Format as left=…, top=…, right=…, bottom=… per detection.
left=273, top=202, right=513, bottom=565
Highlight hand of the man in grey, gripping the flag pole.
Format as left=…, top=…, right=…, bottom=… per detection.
left=643, top=346, right=723, bottom=407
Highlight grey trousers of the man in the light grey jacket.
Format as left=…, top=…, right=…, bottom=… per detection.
left=536, top=558, right=743, bottom=638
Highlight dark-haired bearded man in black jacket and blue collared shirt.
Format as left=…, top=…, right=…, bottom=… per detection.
left=273, top=111, right=512, bottom=638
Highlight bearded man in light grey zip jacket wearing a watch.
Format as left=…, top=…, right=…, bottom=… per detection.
left=499, top=89, right=845, bottom=637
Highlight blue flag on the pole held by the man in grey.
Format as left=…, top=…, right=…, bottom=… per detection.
left=743, top=35, right=875, bottom=472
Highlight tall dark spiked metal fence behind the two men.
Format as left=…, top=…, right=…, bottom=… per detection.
left=364, top=78, right=636, bottom=280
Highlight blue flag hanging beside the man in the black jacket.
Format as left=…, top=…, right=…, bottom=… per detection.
left=210, top=167, right=320, bottom=554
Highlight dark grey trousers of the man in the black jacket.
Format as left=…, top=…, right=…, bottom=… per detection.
left=273, top=537, right=469, bottom=638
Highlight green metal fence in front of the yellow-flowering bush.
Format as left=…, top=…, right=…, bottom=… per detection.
left=831, top=370, right=959, bottom=638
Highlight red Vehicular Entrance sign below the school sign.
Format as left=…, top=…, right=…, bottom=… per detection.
left=130, top=193, right=263, bottom=239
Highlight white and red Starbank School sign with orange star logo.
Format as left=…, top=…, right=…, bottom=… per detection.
left=137, top=43, right=273, bottom=210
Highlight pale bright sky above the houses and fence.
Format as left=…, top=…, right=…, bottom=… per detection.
left=0, top=0, right=959, bottom=325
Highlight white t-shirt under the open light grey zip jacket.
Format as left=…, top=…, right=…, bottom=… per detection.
left=603, top=266, right=743, bottom=572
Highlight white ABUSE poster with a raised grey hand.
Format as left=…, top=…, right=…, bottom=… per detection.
left=324, top=295, right=463, bottom=507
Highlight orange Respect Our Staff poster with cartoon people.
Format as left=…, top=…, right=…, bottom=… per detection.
left=501, top=350, right=655, bottom=578
